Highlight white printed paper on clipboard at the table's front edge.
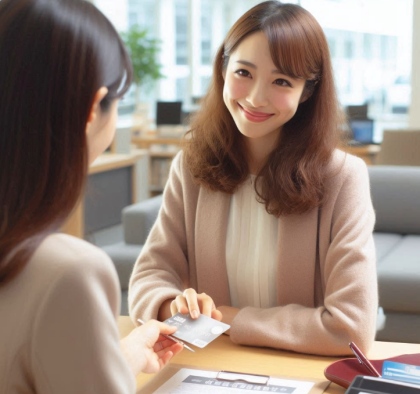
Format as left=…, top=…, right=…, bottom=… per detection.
left=155, top=368, right=315, bottom=394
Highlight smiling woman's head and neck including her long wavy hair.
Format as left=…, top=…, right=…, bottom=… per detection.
left=184, top=2, right=343, bottom=215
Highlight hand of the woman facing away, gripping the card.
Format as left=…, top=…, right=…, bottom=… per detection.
left=120, top=320, right=183, bottom=376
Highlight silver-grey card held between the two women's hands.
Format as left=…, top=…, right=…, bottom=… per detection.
left=165, top=313, right=230, bottom=348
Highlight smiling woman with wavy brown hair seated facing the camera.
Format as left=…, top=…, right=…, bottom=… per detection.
left=129, top=1, right=378, bottom=355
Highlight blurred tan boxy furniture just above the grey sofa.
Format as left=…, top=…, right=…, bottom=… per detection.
left=375, top=130, right=420, bottom=166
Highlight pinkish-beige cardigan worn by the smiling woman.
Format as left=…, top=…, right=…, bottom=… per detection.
left=129, top=150, right=378, bottom=355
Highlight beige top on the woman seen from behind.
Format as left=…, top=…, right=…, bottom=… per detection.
left=0, top=234, right=136, bottom=394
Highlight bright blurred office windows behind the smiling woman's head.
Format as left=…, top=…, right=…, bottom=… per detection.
left=92, top=0, right=420, bottom=142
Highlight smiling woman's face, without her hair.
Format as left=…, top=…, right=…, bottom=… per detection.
left=223, top=32, right=305, bottom=147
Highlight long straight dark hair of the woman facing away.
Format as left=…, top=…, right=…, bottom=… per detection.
left=0, top=0, right=132, bottom=284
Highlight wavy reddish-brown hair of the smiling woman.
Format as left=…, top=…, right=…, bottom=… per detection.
left=184, top=1, right=342, bottom=216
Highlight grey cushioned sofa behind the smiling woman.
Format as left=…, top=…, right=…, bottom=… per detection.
left=104, top=165, right=420, bottom=343
